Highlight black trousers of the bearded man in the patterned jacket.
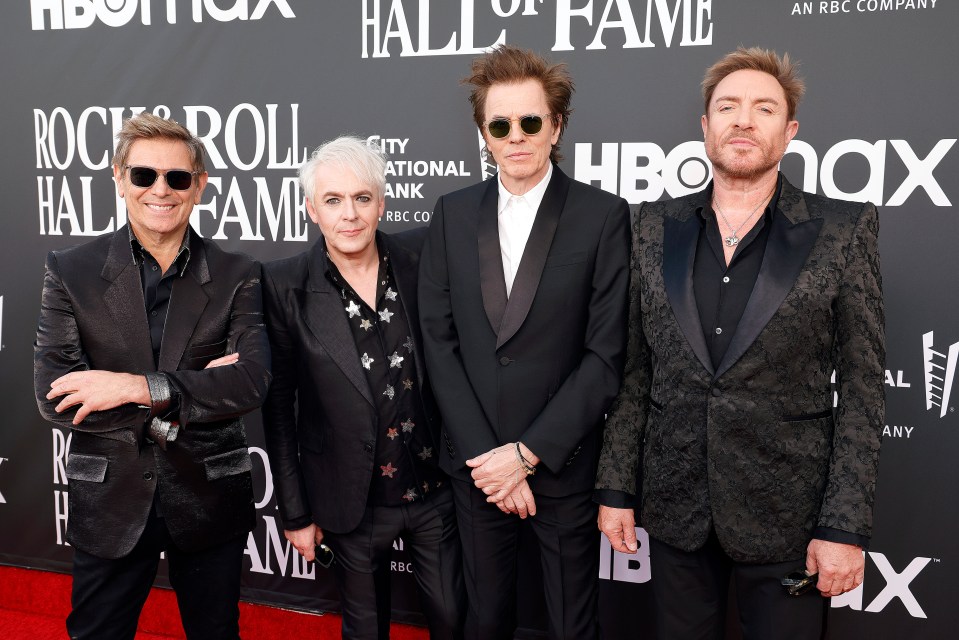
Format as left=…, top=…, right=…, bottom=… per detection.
left=649, top=532, right=829, bottom=640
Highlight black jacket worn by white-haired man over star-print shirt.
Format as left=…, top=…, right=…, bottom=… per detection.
left=263, top=229, right=439, bottom=533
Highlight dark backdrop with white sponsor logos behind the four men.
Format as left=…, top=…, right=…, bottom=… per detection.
left=0, top=0, right=959, bottom=640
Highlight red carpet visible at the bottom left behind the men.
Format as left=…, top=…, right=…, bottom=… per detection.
left=0, top=566, right=429, bottom=640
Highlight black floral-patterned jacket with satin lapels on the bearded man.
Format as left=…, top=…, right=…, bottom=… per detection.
left=597, top=179, right=885, bottom=562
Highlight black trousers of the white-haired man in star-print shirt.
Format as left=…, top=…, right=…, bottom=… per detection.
left=323, top=490, right=466, bottom=640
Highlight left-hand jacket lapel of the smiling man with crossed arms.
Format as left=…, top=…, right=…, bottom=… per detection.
left=100, top=226, right=156, bottom=372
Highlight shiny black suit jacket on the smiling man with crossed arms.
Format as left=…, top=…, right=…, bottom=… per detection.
left=34, top=227, right=270, bottom=558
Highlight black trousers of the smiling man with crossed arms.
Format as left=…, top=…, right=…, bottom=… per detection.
left=67, top=502, right=246, bottom=640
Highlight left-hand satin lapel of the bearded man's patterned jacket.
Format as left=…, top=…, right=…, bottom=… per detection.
left=663, top=195, right=713, bottom=374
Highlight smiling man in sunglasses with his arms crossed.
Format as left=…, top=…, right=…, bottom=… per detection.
left=34, top=113, right=270, bottom=640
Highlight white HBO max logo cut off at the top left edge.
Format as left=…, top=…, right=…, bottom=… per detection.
left=30, top=0, right=296, bottom=31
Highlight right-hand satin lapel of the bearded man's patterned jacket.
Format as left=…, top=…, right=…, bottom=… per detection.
left=716, top=178, right=823, bottom=377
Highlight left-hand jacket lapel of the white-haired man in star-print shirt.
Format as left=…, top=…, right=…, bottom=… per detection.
left=303, top=237, right=373, bottom=405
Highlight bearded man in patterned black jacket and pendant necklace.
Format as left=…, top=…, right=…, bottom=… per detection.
left=597, top=48, right=885, bottom=640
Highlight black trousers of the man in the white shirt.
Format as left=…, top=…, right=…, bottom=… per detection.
left=452, top=480, right=599, bottom=640
